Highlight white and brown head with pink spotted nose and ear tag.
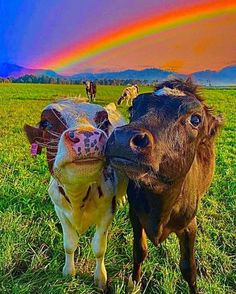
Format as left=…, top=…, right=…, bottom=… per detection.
left=25, top=100, right=111, bottom=183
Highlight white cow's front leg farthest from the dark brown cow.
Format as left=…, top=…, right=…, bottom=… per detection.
left=56, top=209, right=78, bottom=276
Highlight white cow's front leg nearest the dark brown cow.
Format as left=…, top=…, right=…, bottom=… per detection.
left=92, top=215, right=112, bottom=290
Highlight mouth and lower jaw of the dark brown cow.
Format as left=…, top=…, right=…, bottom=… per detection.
left=109, top=156, right=173, bottom=185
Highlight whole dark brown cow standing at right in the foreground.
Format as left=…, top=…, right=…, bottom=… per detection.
left=106, top=79, right=222, bottom=293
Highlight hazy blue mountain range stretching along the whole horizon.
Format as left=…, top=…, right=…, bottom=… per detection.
left=0, top=63, right=236, bottom=85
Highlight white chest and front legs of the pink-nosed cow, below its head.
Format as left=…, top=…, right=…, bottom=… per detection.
left=48, top=169, right=124, bottom=288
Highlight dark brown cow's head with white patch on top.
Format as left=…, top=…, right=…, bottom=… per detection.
left=106, top=79, right=222, bottom=186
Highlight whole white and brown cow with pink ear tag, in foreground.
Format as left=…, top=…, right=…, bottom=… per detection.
left=24, top=100, right=126, bottom=290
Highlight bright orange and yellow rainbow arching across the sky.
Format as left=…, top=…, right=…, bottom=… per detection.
left=37, top=0, right=236, bottom=71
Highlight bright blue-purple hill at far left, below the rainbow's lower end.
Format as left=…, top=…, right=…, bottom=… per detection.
left=0, top=63, right=59, bottom=78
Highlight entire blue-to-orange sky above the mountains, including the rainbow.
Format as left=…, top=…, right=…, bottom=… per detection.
left=0, top=0, right=236, bottom=74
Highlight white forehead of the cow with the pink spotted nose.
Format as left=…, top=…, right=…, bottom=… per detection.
left=44, top=101, right=106, bottom=127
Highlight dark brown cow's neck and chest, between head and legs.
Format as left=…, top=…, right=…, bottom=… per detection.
left=133, top=140, right=214, bottom=245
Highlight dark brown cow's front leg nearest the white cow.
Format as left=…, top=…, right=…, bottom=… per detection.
left=128, top=208, right=147, bottom=291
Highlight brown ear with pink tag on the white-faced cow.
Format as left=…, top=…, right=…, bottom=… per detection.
left=24, top=125, right=45, bottom=155
